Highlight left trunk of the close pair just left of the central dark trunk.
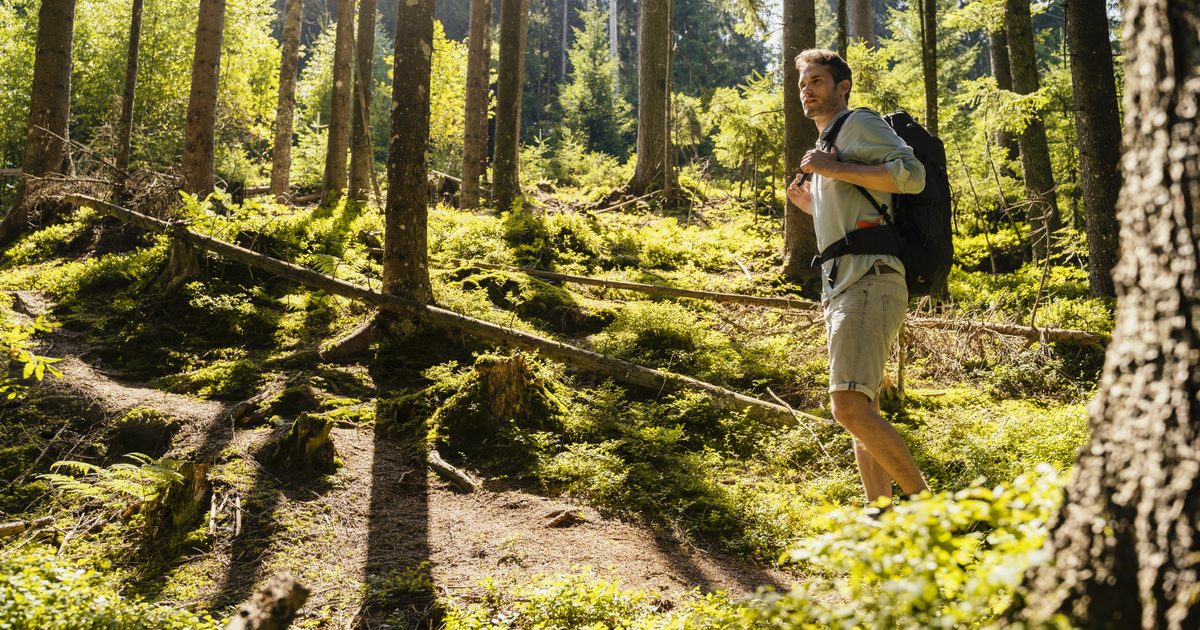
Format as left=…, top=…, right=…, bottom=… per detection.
left=320, top=0, right=354, bottom=200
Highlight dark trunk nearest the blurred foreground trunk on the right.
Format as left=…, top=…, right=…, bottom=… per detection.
left=1067, top=0, right=1121, bottom=296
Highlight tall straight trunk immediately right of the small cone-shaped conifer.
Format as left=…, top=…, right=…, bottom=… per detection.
left=628, top=0, right=671, bottom=197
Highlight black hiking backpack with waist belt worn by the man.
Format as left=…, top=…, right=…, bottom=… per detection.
left=821, top=110, right=954, bottom=298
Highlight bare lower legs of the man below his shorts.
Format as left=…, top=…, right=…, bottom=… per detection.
left=829, top=391, right=929, bottom=499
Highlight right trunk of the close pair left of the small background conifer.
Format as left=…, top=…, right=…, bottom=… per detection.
left=492, top=0, right=529, bottom=211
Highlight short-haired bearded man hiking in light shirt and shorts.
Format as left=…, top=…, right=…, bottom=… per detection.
left=787, top=48, right=928, bottom=503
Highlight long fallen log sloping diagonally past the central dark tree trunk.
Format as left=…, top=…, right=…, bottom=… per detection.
left=64, top=194, right=796, bottom=426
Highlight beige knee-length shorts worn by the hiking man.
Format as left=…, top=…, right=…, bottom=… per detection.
left=824, top=268, right=908, bottom=401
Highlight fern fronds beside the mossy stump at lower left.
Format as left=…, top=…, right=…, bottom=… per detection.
left=40, top=452, right=184, bottom=512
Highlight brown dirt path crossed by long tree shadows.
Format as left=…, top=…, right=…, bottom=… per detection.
left=19, top=294, right=791, bottom=628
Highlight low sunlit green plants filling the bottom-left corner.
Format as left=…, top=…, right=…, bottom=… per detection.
left=0, top=545, right=221, bottom=630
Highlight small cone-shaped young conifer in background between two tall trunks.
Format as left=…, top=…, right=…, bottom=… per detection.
left=558, top=8, right=634, bottom=155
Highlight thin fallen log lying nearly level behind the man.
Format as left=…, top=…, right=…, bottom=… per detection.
left=451, top=258, right=1109, bottom=347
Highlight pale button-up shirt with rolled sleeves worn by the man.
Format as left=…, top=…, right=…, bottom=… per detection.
left=811, top=109, right=925, bottom=302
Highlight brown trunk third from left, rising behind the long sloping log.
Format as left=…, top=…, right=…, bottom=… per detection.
left=182, top=0, right=224, bottom=198
